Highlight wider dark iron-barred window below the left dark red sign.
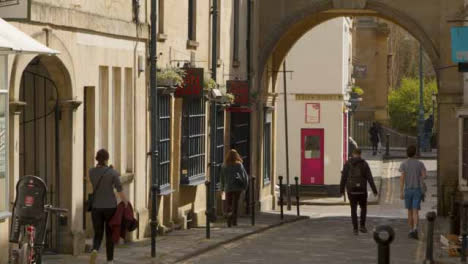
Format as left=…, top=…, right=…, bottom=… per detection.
left=181, top=97, right=206, bottom=185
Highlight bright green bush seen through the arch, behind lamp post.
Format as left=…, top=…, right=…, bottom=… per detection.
left=388, top=78, right=437, bottom=135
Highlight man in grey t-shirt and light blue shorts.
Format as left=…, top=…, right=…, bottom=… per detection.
left=400, top=146, right=426, bottom=239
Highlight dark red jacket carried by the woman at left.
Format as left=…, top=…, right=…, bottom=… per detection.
left=109, top=202, right=138, bottom=243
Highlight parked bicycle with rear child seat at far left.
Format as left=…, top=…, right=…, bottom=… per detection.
left=9, top=176, right=68, bottom=264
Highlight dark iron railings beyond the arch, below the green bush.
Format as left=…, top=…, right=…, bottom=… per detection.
left=352, top=121, right=417, bottom=148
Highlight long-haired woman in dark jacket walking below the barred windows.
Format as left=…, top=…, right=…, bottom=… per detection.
left=220, top=149, right=249, bottom=227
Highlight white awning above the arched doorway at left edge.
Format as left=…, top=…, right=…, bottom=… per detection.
left=0, top=18, right=59, bottom=55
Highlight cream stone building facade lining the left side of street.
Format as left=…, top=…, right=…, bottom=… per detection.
left=0, top=0, right=273, bottom=264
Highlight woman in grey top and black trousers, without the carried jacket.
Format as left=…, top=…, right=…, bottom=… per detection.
left=89, top=149, right=128, bottom=264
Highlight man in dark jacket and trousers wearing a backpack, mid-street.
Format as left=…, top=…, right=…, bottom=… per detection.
left=340, top=149, right=377, bottom=235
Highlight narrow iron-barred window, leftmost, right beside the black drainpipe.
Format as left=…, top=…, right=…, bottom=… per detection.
left=158, top=94, right=172, bottom=195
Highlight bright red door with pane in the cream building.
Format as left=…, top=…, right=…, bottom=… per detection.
left=301, top=129, right=325, bottom=185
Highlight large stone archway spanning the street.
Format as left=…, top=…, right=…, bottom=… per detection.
left=251, top=0, right=464, bottom=214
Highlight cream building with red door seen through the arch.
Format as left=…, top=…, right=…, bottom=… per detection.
left=276, top=18, right=353, bottom=196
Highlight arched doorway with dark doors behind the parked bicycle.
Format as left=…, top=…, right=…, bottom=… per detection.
left=10, top=55, right=73, bottom=253
